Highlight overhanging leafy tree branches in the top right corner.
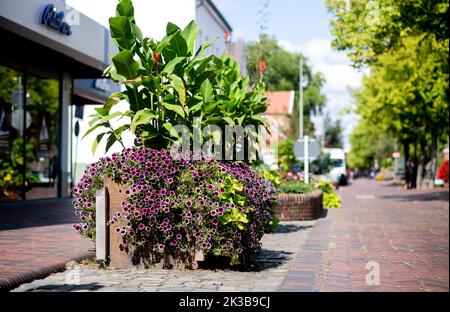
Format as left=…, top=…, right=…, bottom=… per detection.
left=326, top=0, right=449, bottom=67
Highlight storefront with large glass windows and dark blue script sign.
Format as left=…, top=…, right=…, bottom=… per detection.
left=0, top=0, right=117, bottom=201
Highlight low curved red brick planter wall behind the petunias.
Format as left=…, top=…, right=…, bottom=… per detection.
left=276, top=190, right=323, bottom=221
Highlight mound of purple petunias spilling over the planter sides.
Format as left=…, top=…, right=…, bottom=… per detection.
left=73, top=147, right=274, bottom=264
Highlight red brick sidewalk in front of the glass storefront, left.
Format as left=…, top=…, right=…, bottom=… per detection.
left=0, top=200, right=94, bottom=290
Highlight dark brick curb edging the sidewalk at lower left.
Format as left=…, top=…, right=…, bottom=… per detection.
left=0, top=252, right=95, bottom=292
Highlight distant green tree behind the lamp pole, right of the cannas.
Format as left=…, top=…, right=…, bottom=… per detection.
left=247, top=35, right=326, bottom=135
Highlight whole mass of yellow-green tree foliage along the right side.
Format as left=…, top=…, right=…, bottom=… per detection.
left=326, top=0, right=449, bottom=178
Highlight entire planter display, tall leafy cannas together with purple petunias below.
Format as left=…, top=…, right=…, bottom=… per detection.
left=73, top=0, right=274, bottom=268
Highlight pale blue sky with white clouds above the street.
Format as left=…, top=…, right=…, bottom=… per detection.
left=65, top=0, right=362, bottom=150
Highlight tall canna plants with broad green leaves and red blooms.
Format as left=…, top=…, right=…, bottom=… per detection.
left=85, top=0, right=267, bottom=153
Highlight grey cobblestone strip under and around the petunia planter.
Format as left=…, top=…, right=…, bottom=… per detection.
left=13, top=221, right=316, bottom=292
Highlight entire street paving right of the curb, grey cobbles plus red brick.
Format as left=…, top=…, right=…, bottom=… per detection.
left=6, top=180, right=449, bottom=291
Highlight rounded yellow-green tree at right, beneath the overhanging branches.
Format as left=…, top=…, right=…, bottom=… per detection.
left=354, top=35, right=449, bottom=183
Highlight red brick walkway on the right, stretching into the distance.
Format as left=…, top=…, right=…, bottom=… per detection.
left=280, top=180, right=449, bottom=291
